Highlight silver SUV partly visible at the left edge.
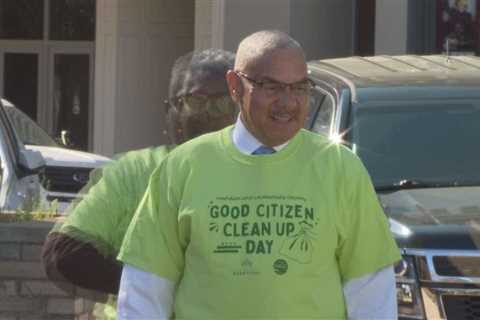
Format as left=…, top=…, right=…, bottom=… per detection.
left=0, top=99, right=109, bottom=213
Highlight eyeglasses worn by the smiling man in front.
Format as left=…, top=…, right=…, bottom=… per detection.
left=235, top=71, right=315, bottom=98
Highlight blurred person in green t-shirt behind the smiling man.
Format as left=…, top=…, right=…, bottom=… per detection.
left=43, top=49, right=237, bottom=295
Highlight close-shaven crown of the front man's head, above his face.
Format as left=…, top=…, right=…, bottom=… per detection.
left=235, top=30, right=304, bottom=72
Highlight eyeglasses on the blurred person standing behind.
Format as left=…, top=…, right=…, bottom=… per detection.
left=172, top=93, right=238, bottom=116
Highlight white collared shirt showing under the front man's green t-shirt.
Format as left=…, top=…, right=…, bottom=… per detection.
left=117, top=115, right=397, bottom=320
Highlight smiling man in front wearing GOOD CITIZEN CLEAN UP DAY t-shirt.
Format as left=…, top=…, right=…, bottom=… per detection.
left=117, top=31, right=400, bottom=319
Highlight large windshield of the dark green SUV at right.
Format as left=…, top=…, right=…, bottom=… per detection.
left=349, top=101, right=480, bottom=189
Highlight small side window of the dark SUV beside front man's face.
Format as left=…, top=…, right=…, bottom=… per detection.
left=310, top=88, right=334, bottom=136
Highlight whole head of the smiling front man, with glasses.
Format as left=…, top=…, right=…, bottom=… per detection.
left=227, top=31, right=310, bottom=147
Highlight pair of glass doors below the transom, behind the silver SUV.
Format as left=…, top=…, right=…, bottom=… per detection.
left=0, top=43, right=94, bottom=150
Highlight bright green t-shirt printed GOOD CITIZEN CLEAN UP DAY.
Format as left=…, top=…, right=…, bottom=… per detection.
left=119, top=127, right=400, bottom=320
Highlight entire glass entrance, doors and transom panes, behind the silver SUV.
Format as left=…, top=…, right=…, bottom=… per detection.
left=0, top=0, right=96, bottom=150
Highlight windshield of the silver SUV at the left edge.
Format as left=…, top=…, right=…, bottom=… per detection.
left=4, top=105, right=59, bottom=147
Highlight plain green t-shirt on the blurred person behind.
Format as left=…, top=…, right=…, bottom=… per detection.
left=56, top=146, right=172, bottom=256
